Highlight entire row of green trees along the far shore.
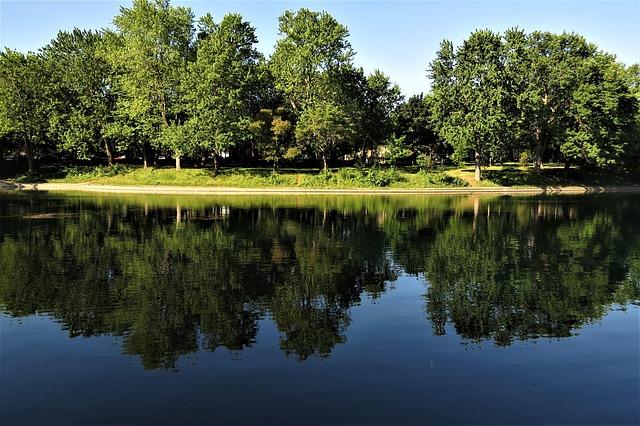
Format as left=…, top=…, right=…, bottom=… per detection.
left=0, top=0, right=640, bottom=179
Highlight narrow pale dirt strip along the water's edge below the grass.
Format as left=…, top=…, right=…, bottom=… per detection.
left=0, top=181, right=640, bottom=195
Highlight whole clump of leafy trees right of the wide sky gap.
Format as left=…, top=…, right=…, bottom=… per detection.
left=430, top=28, right=640, bottom=180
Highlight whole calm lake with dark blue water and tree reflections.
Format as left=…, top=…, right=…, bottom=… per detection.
left=0, top=193, right=640, bottom=425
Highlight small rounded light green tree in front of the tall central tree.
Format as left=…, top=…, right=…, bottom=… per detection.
left=295, top=101, right=353, bottom=171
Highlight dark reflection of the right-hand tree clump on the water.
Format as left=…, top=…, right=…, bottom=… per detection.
left=410, top=198, right=639, bottom=345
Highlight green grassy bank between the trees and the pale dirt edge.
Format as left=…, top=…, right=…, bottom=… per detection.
left=10, top=165, right=638, bottom=189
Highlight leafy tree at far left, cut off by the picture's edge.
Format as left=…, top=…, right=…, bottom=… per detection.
left=0, top=49, right=49, bottom=173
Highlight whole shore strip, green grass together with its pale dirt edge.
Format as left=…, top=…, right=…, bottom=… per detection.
left=5, top=165, right=640, bottom=195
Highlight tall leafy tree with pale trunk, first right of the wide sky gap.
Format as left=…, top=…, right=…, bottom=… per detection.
left=430, top=30, right=507, bottom=181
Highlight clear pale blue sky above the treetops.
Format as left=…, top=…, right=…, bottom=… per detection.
left=0, top=0, right=640, bottom=95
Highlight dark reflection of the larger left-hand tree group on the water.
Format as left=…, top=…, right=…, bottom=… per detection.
left=0, top=201, right=394, bottom=368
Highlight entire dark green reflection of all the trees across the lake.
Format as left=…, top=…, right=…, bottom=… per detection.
left=0, top=198, right=640, bottom=368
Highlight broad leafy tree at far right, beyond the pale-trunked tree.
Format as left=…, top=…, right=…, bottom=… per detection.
left=505, top=30, right=637, bottom=169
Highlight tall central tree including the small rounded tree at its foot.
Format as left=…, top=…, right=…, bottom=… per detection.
left=270, top=8, right=366, bottom=169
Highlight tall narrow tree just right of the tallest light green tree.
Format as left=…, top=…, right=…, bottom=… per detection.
left=188, top=14, right=262, bottom=170
